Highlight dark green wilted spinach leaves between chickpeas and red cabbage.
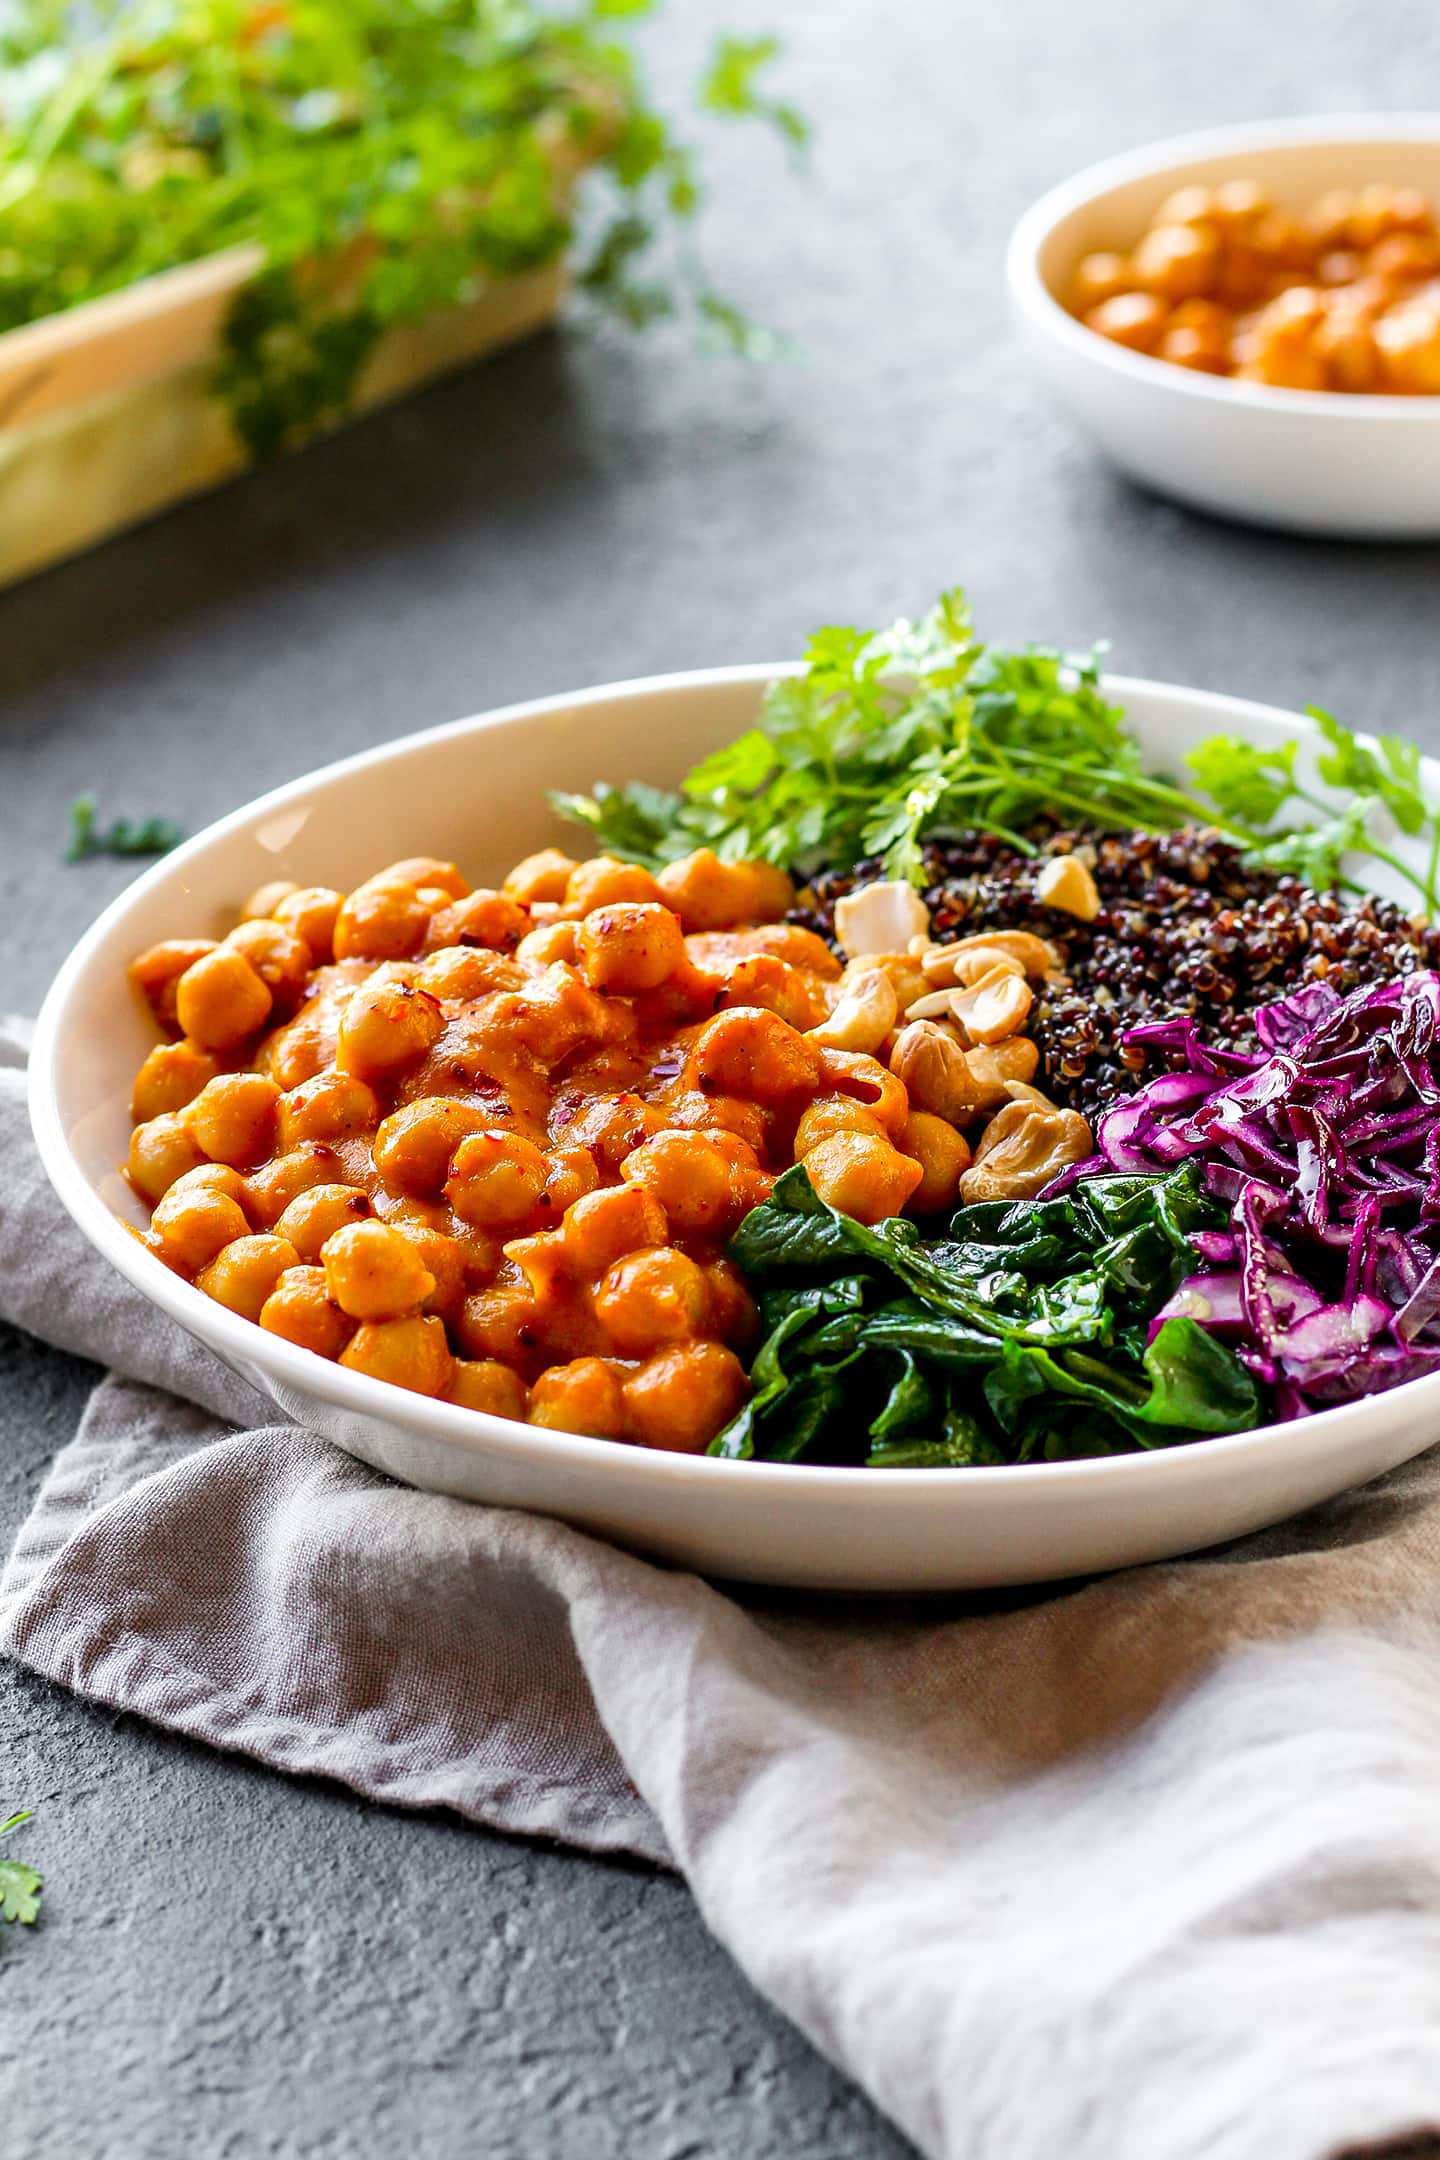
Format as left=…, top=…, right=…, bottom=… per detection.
left=710, top=1164, right=1261, bottom=1469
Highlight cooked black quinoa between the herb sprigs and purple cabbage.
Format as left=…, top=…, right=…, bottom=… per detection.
left=790, top=825, right=1440, bottom=1123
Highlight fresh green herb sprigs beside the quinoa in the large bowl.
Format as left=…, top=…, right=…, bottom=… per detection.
left=553, top=590, right=1440, bottom=909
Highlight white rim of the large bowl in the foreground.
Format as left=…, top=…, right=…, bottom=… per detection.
left=28, top=661, right=1440, bottom=1508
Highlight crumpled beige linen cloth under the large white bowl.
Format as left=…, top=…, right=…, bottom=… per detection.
left=0, top=1010, right=1440, bottom=2160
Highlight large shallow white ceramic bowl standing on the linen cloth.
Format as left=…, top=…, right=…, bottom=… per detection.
left=30, top=667, right=1440, bottom=1592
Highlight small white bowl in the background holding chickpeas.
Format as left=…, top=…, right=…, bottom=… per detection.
left=1006, top=112, right=1440, bottom=540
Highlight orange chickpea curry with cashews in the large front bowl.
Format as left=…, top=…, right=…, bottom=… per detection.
left=127, top=849, right=1095, bottom=1452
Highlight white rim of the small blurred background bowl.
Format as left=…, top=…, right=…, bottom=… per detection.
left=1006, top=112, right=1440, bottom=426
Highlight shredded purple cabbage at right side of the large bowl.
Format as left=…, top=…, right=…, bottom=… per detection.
left=1079, top=972, right=1440, bottom=1417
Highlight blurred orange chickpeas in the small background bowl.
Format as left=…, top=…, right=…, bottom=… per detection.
left=1069, top=179, right=1440, bottom=397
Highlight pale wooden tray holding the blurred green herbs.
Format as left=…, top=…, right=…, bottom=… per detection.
left=0, top=246, right=566, bottom=585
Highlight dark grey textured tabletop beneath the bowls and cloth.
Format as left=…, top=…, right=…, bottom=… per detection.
left=0, top=0, right=1440, bottom=2160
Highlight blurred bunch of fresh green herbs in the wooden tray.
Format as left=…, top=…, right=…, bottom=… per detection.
left=0, top=0, right=805, bottom=458
